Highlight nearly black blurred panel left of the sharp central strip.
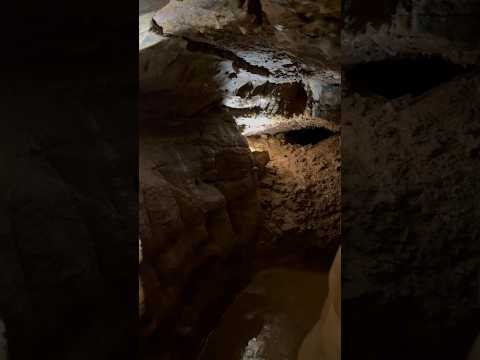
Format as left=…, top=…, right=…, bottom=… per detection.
left=0, top=1, right=138, bottom=360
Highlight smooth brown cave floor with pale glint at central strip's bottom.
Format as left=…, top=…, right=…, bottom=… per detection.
left=199, top=268, right=328, bottom=360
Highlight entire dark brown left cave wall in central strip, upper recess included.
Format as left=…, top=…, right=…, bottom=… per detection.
left=140, top=31, right=261, bottom=356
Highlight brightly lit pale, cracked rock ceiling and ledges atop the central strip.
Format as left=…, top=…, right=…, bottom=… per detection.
left=140, top=1, right=340, bottom=135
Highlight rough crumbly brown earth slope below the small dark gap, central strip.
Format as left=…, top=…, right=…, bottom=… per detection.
left=249, top=129, right=341, bottom=253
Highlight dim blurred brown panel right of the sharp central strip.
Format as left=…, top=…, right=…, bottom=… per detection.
left=342, top=0, right=480, bottom=360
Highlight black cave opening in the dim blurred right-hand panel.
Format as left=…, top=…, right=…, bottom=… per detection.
left=346, top=56, right=468, bottom=99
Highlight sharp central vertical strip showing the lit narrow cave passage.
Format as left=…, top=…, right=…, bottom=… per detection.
left=140, top=1, right=340, bottom=360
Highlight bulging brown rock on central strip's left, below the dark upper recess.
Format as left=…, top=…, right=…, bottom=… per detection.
left=140, top=105, right=261, bottom=348
